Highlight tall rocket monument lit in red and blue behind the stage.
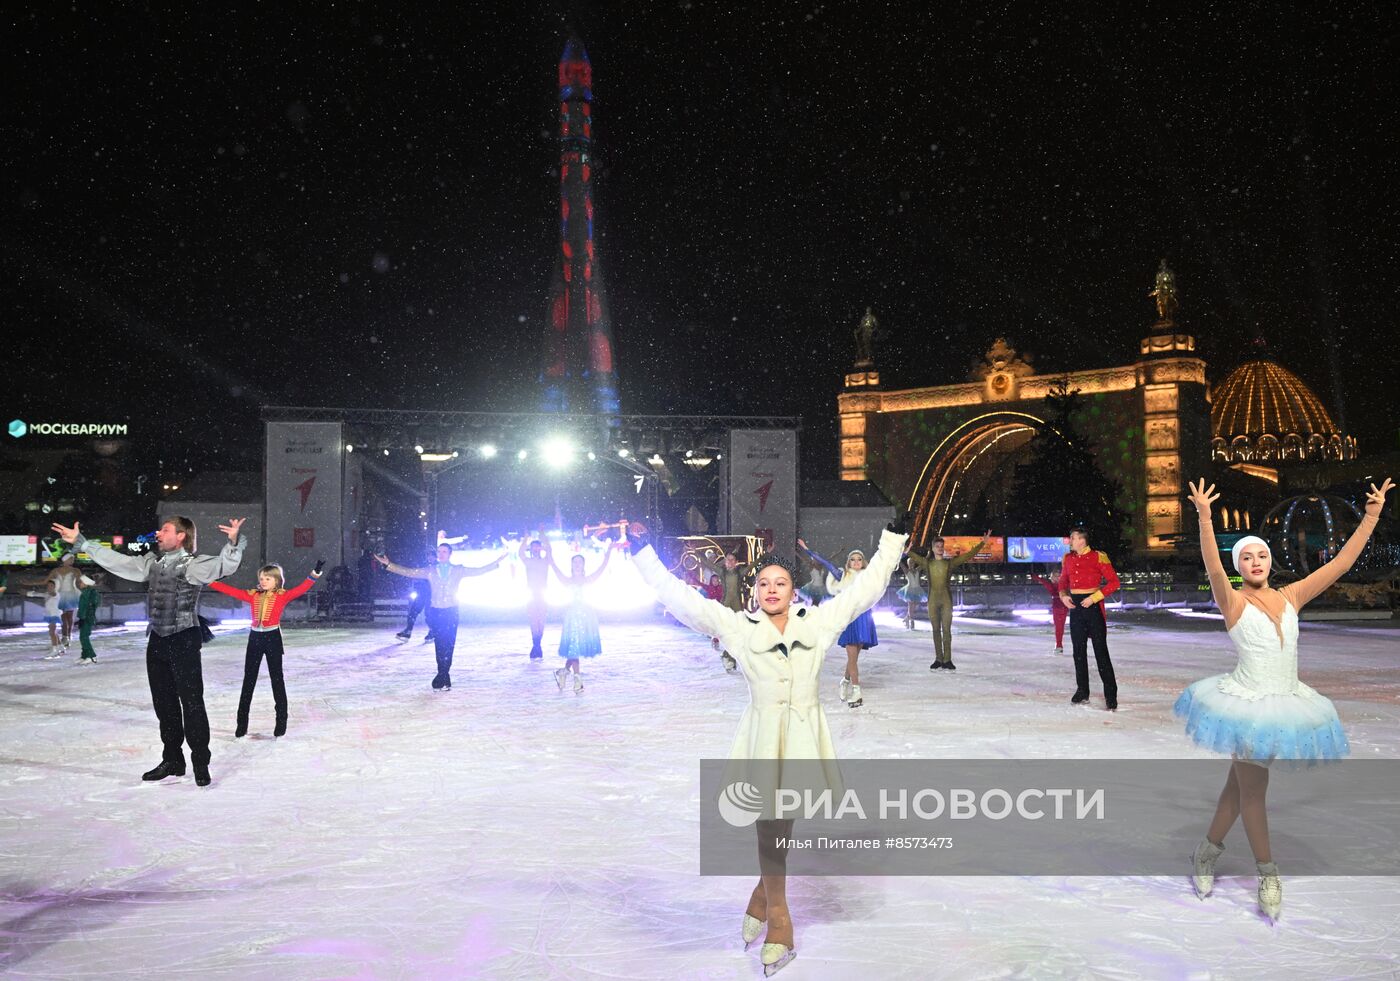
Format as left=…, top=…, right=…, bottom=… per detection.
left=540, top=38, right=619, bottom=425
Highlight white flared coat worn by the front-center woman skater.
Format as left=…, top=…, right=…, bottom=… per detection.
left=634, top=532, right=907, bottom=785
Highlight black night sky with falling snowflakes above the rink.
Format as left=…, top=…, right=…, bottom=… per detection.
left=0, top=0, right=1400, bottom=477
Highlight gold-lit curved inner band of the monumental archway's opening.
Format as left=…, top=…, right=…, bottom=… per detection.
left=907, top=410, right=1047, bottom=546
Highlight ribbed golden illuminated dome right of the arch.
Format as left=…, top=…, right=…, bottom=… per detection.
left=1211, top=361, right=1357, bottom=460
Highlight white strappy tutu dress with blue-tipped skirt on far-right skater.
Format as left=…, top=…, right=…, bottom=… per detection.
left=1172, top=605, right=1351, bottom=764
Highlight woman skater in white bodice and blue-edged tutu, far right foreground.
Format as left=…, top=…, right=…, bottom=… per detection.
left=1175, top=477, right=1394, bottom=919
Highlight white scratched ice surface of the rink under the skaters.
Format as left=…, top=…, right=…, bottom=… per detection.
left=0, top=613, right=1400, bottom=981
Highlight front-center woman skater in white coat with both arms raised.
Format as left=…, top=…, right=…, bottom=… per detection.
left=629, top=516, right=909, bottom=975
